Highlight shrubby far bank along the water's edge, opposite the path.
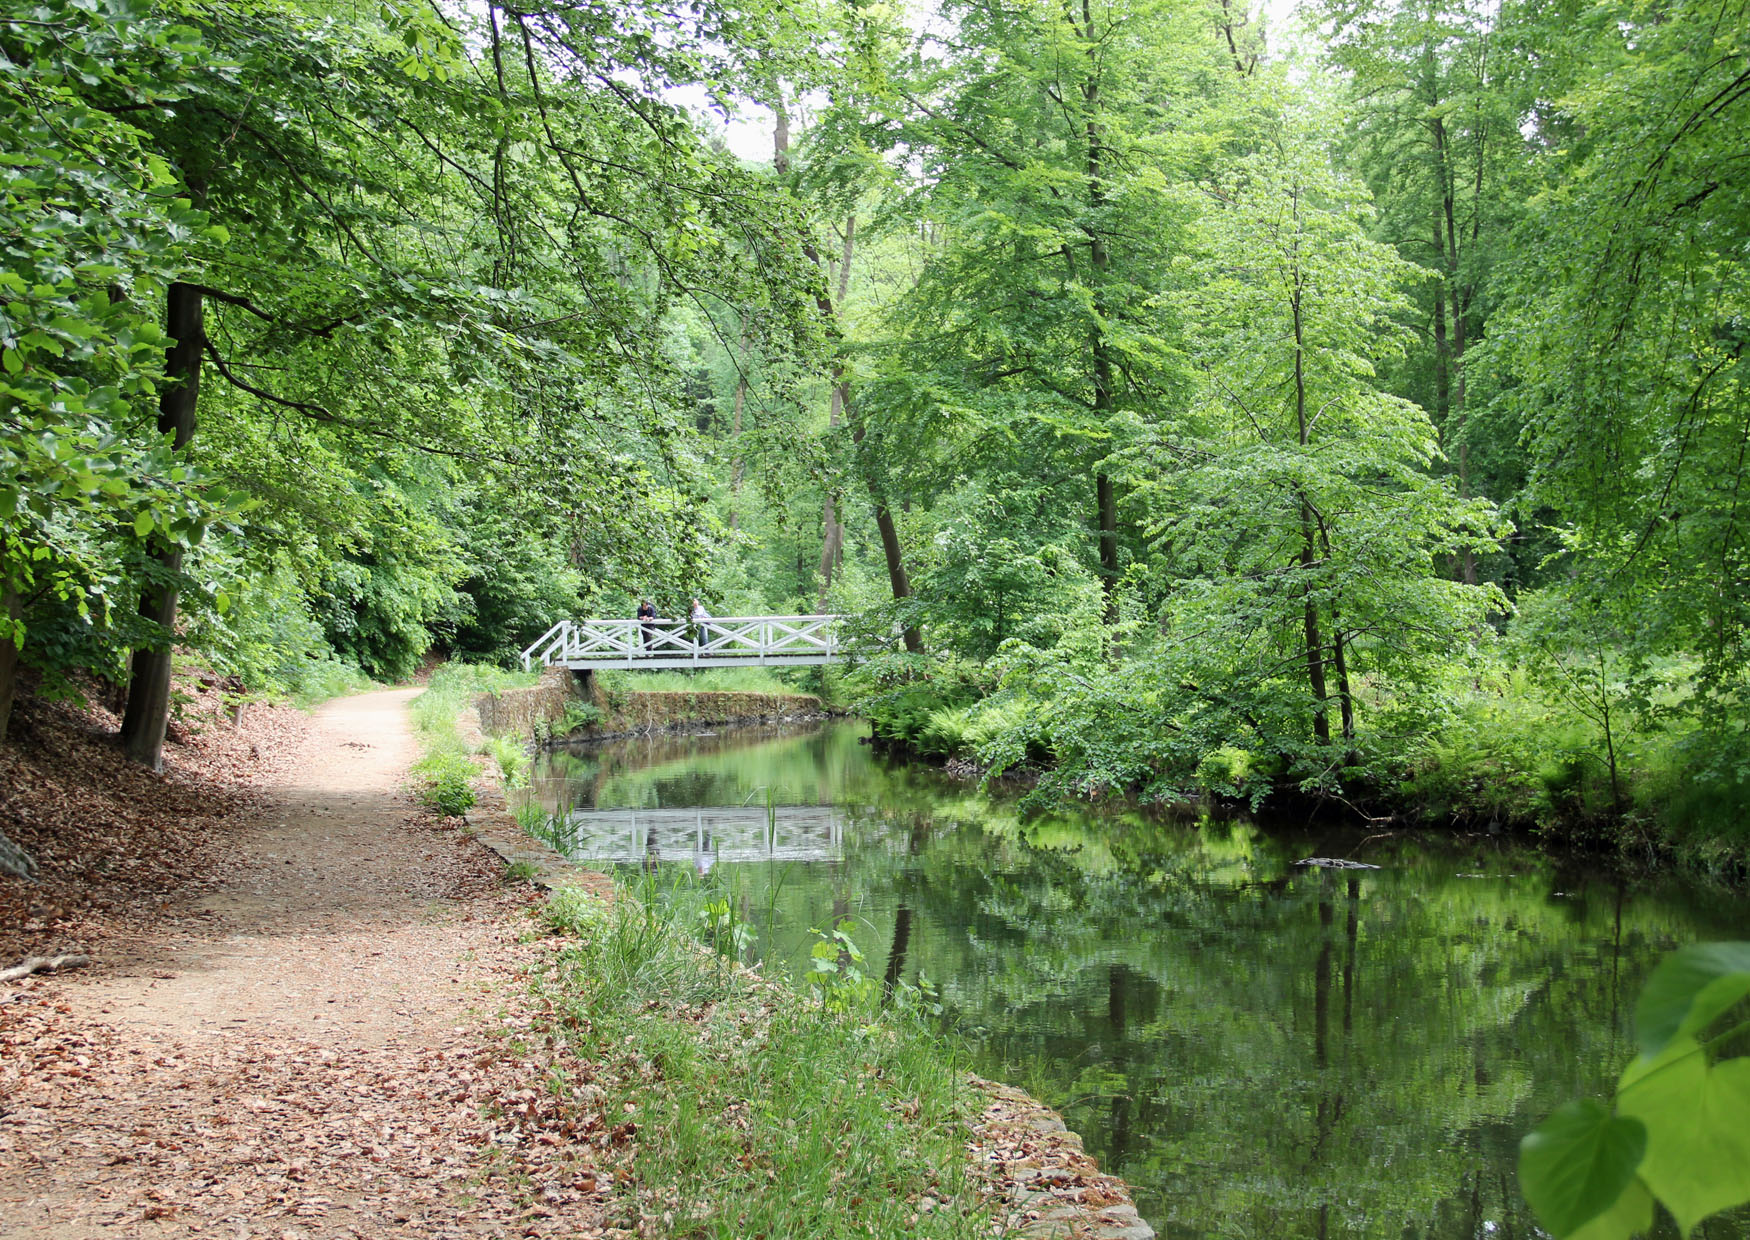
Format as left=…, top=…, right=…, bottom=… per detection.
left=858, top=659, right=1750, bottom=885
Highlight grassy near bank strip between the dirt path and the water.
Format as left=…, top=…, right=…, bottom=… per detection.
left=448, top=685, right=1155, bottom=1240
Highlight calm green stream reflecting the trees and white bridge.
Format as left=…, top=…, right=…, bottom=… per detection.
left=536, top=724, right=1750, bottom=1240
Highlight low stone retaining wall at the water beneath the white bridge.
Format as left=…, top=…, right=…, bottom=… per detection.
left=474, top=668, right=821, bottom=736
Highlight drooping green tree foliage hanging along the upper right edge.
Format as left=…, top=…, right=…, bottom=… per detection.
left=1482, top=2, right=1750, bottom=714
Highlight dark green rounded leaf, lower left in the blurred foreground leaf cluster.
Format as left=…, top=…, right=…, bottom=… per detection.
left=1519, top=1100, right=1647, bottom=1240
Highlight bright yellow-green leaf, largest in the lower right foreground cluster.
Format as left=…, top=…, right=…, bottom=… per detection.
left=1617, top=1037, right=1750, bottom=1235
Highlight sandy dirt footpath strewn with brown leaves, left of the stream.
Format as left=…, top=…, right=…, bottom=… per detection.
left=0, top=689, right=613, bottom=1240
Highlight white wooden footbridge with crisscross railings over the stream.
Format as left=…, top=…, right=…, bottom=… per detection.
left=523, top=616, right=847, bottom=672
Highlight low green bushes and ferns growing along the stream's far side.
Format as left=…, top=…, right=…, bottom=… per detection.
left=852, top=643, right=1750, bottom=878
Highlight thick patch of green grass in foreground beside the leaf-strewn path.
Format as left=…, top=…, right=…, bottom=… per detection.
left=537, top=892, right=989, bottom=1240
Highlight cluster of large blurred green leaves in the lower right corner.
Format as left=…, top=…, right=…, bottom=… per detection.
left=1519, top=943, right=1750, bottom=1240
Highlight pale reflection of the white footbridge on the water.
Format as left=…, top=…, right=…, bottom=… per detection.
left=553, top=805, right=845, bottom=871
